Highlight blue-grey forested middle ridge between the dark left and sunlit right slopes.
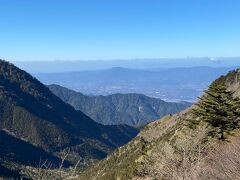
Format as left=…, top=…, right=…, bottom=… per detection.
left=48, top=85, right=191, bottom=127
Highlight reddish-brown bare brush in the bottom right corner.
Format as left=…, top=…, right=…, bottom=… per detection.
left=199, top=133, right=240, bottom=180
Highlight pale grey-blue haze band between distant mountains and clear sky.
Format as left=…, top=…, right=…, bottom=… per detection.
left=14, top=57, right=240, bottom=74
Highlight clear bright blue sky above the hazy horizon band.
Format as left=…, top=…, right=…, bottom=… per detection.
left=0, top=0, right=240, bottom=61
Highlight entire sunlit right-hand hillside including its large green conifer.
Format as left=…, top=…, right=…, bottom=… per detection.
left=79, top=70, right=240, bottom=180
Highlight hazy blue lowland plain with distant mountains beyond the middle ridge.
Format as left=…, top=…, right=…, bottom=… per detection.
left=34, top=66, right=233, bottom=102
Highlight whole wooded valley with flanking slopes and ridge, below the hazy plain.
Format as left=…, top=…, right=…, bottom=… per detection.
left=0, top=60, right=240, bottom=180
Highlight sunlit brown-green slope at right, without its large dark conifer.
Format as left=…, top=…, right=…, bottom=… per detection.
left=79, top=70, right=240, bottom=180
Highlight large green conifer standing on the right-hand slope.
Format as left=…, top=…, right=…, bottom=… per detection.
left=193, top=81, right=240, bottom=140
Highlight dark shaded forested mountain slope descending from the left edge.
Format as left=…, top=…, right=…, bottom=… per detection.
left=0, top=60, right=137, bottom=169
